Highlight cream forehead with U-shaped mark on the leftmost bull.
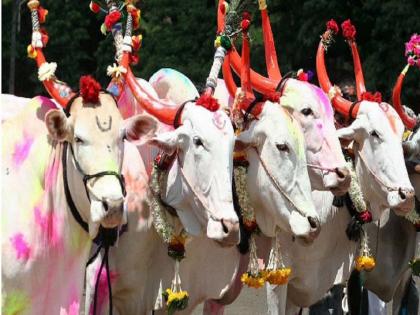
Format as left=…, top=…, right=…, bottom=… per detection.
left=71, top=94, right=123, bottom=140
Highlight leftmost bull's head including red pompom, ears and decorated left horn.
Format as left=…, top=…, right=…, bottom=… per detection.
left=28, top=0, right=156, bottom=237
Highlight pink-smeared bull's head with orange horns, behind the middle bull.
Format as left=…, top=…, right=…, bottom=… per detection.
left=218, top=2, right=350, bottom=195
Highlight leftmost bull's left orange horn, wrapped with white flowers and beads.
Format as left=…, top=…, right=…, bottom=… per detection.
left=28, top=0, right=75, bottom=108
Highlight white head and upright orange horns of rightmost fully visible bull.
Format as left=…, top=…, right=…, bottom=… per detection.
left=316, top=18, right=414, bottom=218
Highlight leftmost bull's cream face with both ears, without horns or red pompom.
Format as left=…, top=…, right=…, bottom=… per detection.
left=45, top=79, right=156, bottom=236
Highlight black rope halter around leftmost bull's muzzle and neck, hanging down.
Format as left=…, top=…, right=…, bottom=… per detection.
left=62, top=142, right=128, bottom=315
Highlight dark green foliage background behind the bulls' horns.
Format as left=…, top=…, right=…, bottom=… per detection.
left=2, top=0, right=420, bottom=107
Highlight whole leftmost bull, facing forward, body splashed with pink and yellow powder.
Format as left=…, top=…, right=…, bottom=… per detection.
left=2, top=0, right=156, bottom=314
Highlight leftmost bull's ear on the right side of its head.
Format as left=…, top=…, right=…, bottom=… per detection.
left=125, top=115, right=157, bottom=141
